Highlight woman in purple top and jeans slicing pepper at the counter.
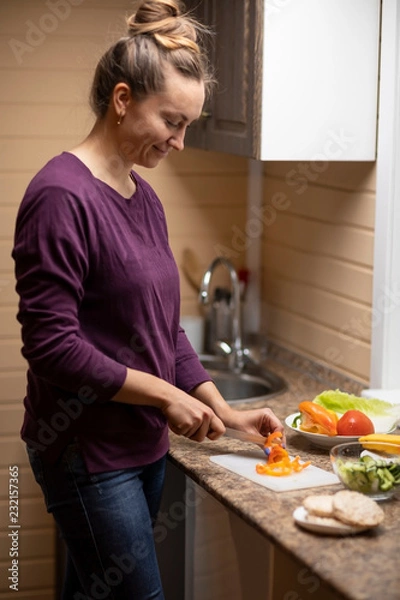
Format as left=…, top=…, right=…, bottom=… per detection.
left=13, top=0, right=283, bottom=600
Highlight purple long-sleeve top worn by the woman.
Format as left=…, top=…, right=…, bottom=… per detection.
left=13, top=152, right=210, bottom=473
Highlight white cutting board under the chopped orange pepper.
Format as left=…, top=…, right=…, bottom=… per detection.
left=210, top=452, right=340, bottom=492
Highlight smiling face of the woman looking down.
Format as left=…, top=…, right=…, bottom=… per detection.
left=118, top=65, right=204, bottom=168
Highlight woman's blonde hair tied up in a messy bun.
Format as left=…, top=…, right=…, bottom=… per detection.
left=90, top=0, right=214, bottom=118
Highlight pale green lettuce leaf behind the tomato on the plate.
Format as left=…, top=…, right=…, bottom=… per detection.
left=313, top=390, right=400, bottom=433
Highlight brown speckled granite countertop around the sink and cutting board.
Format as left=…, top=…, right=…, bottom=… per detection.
left=170, top=350, right=400, bottom=600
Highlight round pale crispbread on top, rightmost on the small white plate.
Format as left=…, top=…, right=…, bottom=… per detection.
left=333, top=490, right=385, bottom=527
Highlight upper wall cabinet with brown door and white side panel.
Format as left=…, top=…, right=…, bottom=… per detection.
left=186, top=0, right=380, bottom=161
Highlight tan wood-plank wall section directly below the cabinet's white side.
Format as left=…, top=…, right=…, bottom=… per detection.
left=262, top=163, right=376, bottom=385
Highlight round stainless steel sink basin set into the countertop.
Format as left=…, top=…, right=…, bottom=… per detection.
left=200, top=355, right=286, bottom=404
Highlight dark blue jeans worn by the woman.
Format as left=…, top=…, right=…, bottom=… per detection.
left=28, top=443, right=166, bottom=600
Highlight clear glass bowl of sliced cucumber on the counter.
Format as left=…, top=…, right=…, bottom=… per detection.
left=330, top=435, right=400, bottom=501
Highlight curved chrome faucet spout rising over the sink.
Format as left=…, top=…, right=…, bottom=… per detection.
left=199, top=256, right=244, bottom=373
